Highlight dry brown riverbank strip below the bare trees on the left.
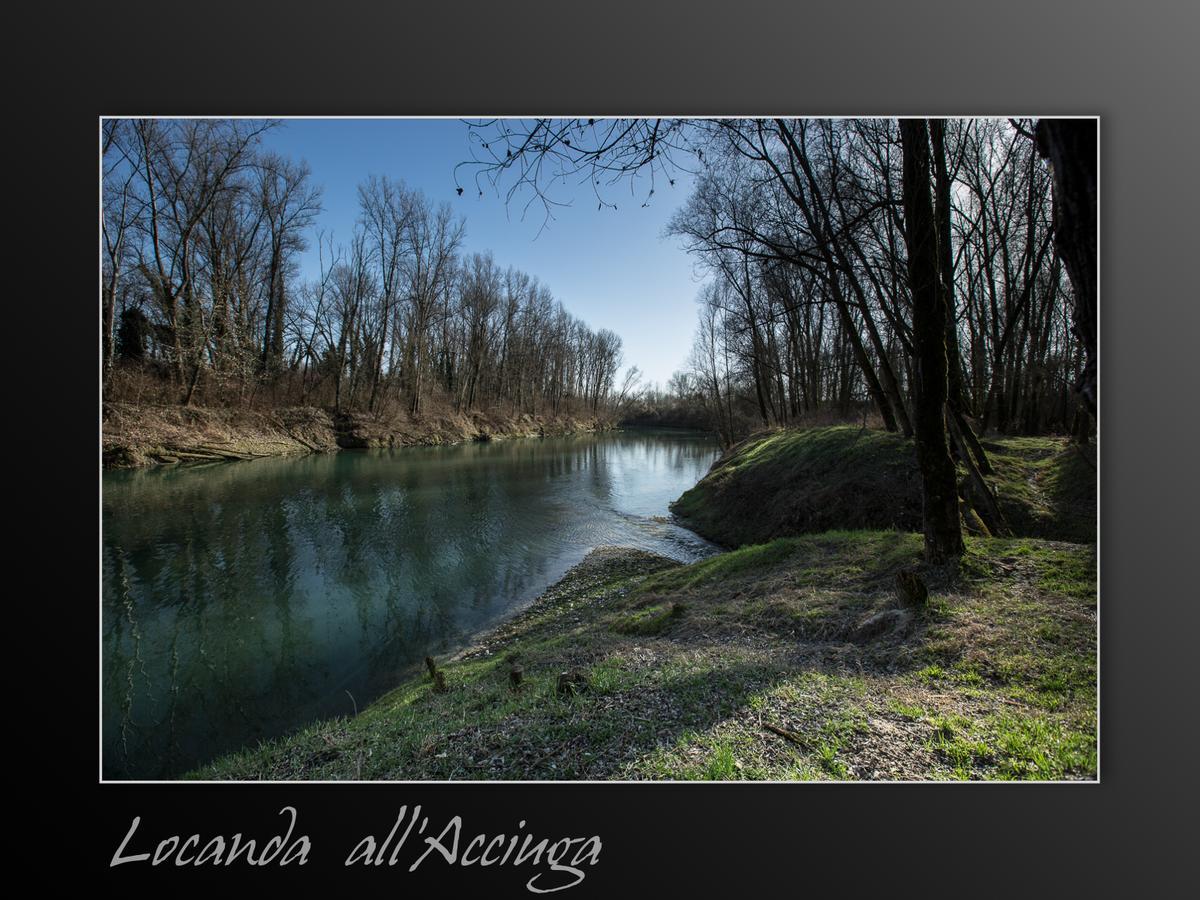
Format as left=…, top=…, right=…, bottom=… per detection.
left=101, top=402, right=618, bottom=469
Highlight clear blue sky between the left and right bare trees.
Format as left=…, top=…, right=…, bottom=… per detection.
left=258, top=119, right=700, bottom=385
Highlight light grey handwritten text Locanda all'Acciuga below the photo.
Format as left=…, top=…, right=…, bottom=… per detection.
left=109, top=804, right=601, bottom=894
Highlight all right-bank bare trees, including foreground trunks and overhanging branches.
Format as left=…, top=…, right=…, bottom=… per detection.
left=467, top=119, right=1097, bottom=562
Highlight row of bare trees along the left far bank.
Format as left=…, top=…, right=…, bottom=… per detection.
left=101, top=119, right=630, bottom=415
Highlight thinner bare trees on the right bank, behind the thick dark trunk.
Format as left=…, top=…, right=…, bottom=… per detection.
left=592, top=120, right=1092, bottom=442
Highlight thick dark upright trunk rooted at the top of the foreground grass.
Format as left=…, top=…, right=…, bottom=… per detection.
left=900, top=119, right=962, bottom=563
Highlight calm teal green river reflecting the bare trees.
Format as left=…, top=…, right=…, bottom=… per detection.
left=102, top=430, right=719, bottom=779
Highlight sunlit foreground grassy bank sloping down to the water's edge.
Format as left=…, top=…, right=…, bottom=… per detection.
left=192, top=532, right=1097, bottom=780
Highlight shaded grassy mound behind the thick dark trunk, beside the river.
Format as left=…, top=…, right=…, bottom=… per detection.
left=671, top=426, right=1096, bottom=547
